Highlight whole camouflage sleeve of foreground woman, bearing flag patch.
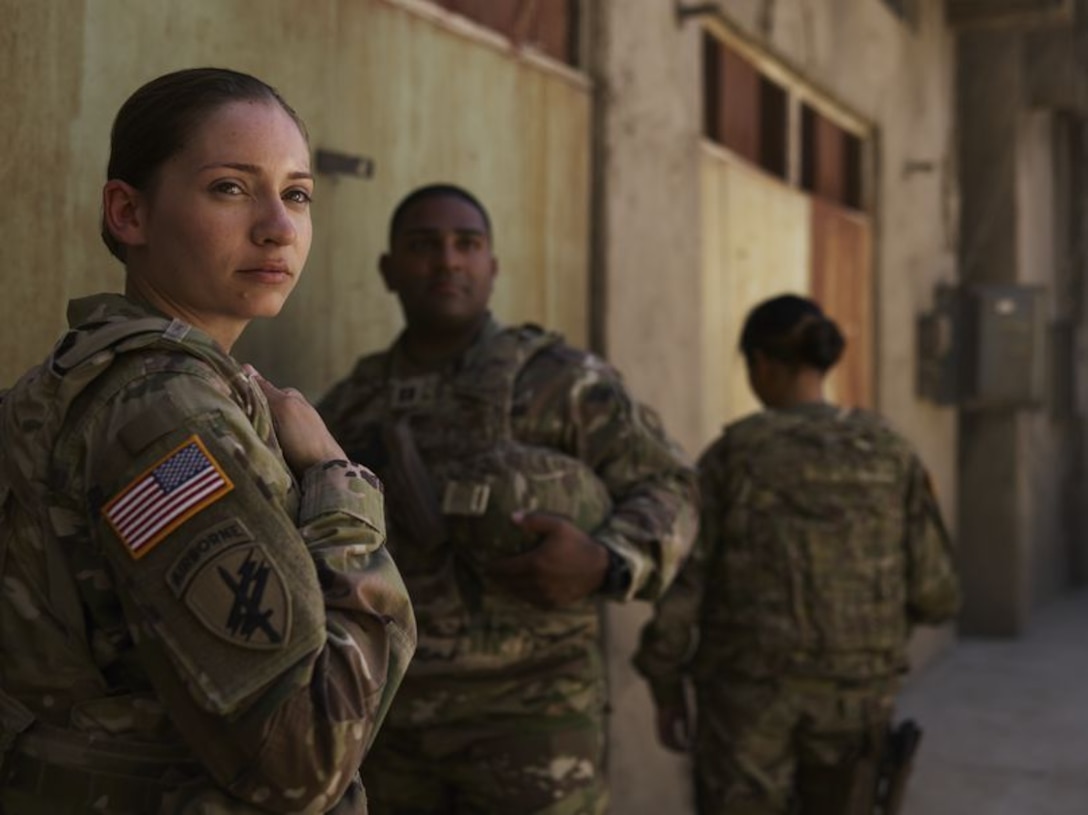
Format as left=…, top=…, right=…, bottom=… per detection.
left=84, top=372, right=416, bottom=813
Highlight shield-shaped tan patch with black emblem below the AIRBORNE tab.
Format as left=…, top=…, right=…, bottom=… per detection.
left=182, top=543, right=290, bottom=650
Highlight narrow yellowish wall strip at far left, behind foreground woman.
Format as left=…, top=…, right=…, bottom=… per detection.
left=0, top=1, right=89, bottom=387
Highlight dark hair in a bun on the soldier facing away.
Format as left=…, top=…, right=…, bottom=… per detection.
left=740, top=294, right=846, bottom=371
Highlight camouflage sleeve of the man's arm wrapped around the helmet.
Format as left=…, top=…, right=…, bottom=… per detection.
left=570, top=357, right=696, bottom=600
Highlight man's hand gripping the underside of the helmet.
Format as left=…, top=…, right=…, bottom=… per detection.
left=489, top=513, right=608, bottom=608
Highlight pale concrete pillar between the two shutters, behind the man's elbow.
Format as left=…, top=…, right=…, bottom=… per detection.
left=591, top=0, right=705, bottom=815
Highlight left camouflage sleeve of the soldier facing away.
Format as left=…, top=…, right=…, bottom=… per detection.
left=632, top=448, right=724, bottom=707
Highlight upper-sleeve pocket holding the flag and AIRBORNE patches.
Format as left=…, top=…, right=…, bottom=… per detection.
left=99, top=410, right=324, bottom=714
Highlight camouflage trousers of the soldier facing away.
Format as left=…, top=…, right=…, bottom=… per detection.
left=694, top=678, right=898, bottom=815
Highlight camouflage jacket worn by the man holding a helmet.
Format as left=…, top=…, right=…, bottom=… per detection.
left=319, top=320, right=695, bottom=726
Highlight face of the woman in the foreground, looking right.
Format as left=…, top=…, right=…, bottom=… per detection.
left=127, top=101, right=313, bottom=348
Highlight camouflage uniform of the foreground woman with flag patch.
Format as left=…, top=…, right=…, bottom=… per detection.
left=0, top=295, right=415, bottom=815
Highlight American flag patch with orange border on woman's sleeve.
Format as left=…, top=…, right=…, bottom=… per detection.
left=102, top=435, right=234, bottom=559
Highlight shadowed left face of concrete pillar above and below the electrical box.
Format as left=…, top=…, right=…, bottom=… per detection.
left=957, top=30, right=1028, bottom=633
